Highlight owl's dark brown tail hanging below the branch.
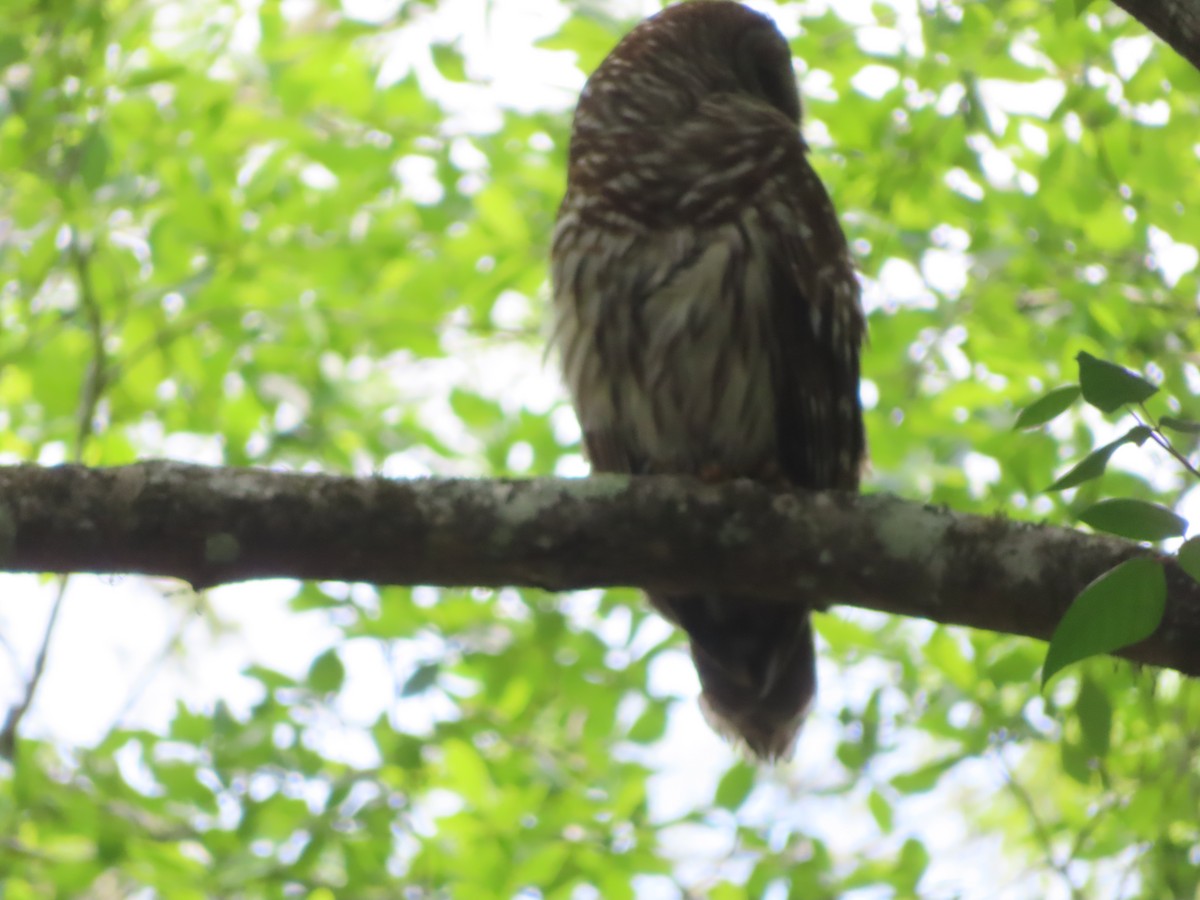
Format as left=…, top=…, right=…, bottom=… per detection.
left=650, top=595, right=817, bottom=761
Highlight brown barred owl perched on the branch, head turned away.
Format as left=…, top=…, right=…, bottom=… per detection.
left=551, top=0, right=864, bottom=760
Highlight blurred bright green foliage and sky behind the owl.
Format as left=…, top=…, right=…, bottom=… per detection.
left=0, top=0, right=1200, bottom=899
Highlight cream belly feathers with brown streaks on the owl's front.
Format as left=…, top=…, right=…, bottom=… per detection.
left=553, top=209, right=778, bottom=474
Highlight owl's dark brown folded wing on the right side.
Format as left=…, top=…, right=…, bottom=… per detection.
left=770, top=157, right=866, bottom=490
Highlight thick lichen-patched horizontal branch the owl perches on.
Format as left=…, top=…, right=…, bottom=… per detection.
left=0, top=462, right=1200, bottom=676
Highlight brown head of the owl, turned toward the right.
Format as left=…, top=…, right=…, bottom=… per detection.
left=580, top=0, right=800, bottom=128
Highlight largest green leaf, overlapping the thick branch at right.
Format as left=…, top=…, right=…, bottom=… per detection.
left=1042, top=558, right=1166, bottom=690
